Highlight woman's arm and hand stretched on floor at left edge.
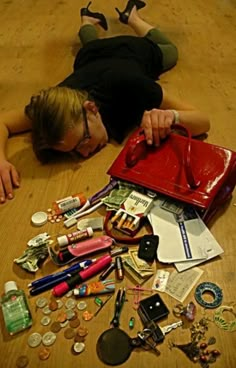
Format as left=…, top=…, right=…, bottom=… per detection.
left=0, top=110, right=31, bottom=203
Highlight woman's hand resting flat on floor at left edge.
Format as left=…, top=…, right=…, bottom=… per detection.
left=0, top=160, right=20, bottom=203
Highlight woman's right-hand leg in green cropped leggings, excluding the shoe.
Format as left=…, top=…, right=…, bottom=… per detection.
left=128, top=7, right=178, bottom=71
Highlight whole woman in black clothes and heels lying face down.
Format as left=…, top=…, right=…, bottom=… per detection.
left=0, top=0, right=210, bottom=203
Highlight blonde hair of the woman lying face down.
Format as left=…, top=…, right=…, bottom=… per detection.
left=25, top=87, right=88, bottom=162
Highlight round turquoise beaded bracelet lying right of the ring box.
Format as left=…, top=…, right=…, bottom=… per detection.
left=195, top=282, right=223, bottom=308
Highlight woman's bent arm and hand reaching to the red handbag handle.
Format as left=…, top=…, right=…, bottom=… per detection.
left=141, top=89, right=210, bottom=146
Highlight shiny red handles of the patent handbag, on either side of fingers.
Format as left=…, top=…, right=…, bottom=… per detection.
left=125, top=124, right=201, bottom=189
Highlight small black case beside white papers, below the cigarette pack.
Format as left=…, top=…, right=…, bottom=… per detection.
left=138, top=235, right=159, bottom=262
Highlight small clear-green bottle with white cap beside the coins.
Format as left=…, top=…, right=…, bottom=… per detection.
left=1, top=281, right=32, bottom=335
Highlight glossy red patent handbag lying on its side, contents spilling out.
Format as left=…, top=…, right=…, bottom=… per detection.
left=107, top=124, right=236, bottom=223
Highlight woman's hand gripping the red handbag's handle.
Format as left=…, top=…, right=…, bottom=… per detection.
left=141, top=109, right=175, bottom=146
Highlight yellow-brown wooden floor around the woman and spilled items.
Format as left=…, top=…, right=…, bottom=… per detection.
left=0, top=0, right=236, bottom=368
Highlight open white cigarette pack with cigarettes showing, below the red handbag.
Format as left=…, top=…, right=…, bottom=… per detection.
left=111, top=190, right=153, bottom=236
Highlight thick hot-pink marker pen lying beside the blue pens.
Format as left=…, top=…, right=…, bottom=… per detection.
left=52, top=255, right=112, bottom=297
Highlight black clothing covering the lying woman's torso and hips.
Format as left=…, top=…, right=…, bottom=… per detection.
left=59, top=36, right=162, bottom=143
